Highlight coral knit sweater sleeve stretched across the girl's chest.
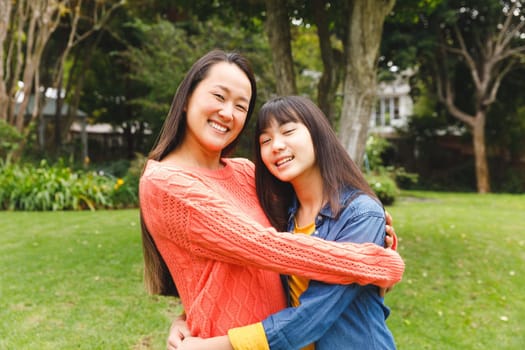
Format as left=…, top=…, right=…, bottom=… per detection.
left=141, top=169, right=404, bottom=287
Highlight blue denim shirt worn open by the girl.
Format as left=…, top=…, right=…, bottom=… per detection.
left=262, top=189, right=396, bottom=350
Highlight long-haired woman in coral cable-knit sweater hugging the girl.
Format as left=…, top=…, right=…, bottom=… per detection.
left=139, top=51, right=404, bottom=338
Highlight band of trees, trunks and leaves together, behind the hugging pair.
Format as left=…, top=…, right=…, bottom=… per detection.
left=0, top=0, right=525, bottom=192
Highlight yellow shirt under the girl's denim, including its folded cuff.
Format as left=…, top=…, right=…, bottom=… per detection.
left=228, top=222, right=315, bottom=350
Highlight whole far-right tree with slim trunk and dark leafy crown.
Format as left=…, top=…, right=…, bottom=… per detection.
left=384, top=0, right=525, bottom=193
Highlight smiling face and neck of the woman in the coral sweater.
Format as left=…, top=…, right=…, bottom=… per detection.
left=183, top=62, right=252, bottom=157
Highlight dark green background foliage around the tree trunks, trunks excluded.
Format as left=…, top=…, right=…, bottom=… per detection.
left=0, top=0, right=525, bottom=193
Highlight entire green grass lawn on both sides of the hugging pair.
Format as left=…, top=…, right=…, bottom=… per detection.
left=0, top=192, right=525, bottom=350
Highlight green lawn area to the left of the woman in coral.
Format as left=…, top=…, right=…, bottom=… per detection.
left=0, top=210, right=179, bottom=350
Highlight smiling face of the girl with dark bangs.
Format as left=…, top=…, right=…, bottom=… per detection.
left=259, top=119, right=319, bottom=184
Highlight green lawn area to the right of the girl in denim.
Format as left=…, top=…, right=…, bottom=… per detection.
left=386, top=192, right=525, bottom=349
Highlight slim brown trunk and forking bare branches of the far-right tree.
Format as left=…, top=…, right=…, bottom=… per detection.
left=432, top=6, right=525, bottom=193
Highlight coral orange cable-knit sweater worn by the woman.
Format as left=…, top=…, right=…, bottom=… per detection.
left=139, top=158, right=404, bottom=338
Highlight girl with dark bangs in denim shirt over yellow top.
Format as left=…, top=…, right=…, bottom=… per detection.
left=174, top=96, right=395, bottom=350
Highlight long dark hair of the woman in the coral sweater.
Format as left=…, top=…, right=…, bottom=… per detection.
left=140, top=50, right=257, bottom=296
